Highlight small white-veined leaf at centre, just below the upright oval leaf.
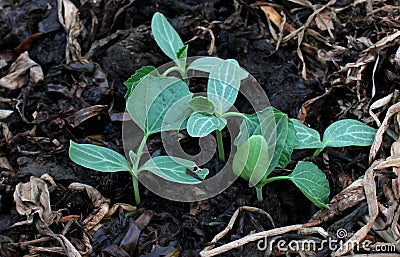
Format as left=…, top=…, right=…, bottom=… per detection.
left=187, top=112, right=226, bottom=137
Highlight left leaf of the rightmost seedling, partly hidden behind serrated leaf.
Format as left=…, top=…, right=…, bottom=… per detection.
left=290, top=119, right=325, bottom=149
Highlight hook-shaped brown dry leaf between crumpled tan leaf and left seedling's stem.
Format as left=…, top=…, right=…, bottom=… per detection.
left=68, top=183, right=110, bottom=231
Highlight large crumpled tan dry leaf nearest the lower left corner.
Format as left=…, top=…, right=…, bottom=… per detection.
left=14, top=176, right=57, bottom=226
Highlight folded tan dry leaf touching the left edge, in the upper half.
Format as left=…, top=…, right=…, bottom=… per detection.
left=0, top=52, right=44, bottom=90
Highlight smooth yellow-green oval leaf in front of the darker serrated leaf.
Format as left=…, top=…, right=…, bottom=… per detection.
left=232, top=135, right=270, bottom=186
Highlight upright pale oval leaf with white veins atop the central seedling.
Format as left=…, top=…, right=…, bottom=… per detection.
left=207, top=61, right=240, bottom=115
